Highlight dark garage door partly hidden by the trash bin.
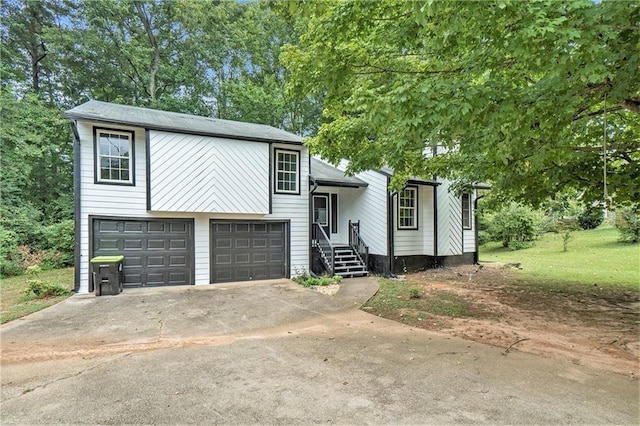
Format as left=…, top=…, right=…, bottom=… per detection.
left=91, top=218, right=194, bottom=287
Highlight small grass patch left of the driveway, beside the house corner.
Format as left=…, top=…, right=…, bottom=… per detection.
left=0, top=268, right=74, bottom=324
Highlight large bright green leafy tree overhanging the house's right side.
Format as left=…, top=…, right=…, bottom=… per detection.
left=277, top=0, right=640, bottom=203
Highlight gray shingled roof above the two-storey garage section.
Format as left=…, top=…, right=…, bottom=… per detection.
left=64, top=101, right=302, bottom=145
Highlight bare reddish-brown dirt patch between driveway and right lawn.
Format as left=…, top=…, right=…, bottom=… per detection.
left=407, top=265, right=640, bottom=377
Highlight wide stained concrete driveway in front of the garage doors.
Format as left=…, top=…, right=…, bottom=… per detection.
left=0, top=279, right=640, bottom=425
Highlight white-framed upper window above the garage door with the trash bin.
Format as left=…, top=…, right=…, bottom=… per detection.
left=94, top=129, right=135, bottom=185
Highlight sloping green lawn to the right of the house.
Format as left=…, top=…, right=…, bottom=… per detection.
left=480, top=226, right=640, bottom=289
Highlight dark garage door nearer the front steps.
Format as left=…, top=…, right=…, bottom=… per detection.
left=211, top=221, right=289, bottom=283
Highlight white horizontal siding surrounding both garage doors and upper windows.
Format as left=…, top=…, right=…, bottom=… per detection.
left=78, top=122, right=309, bottom=293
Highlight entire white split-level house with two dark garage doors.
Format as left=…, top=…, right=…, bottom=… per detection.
left=64, top=101, right=476, bottom=293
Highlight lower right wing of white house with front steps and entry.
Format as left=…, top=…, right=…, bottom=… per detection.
left=310, top=158, right=478, bottom=274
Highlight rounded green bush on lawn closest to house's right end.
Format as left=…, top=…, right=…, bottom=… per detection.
left=490, top=202, right=541, bottom=248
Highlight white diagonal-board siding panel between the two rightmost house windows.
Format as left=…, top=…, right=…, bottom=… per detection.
left=436, top=180, right=463, bottom=256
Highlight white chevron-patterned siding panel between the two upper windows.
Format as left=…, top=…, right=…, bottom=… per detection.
left=149, top=131, right=269, bottom=214
